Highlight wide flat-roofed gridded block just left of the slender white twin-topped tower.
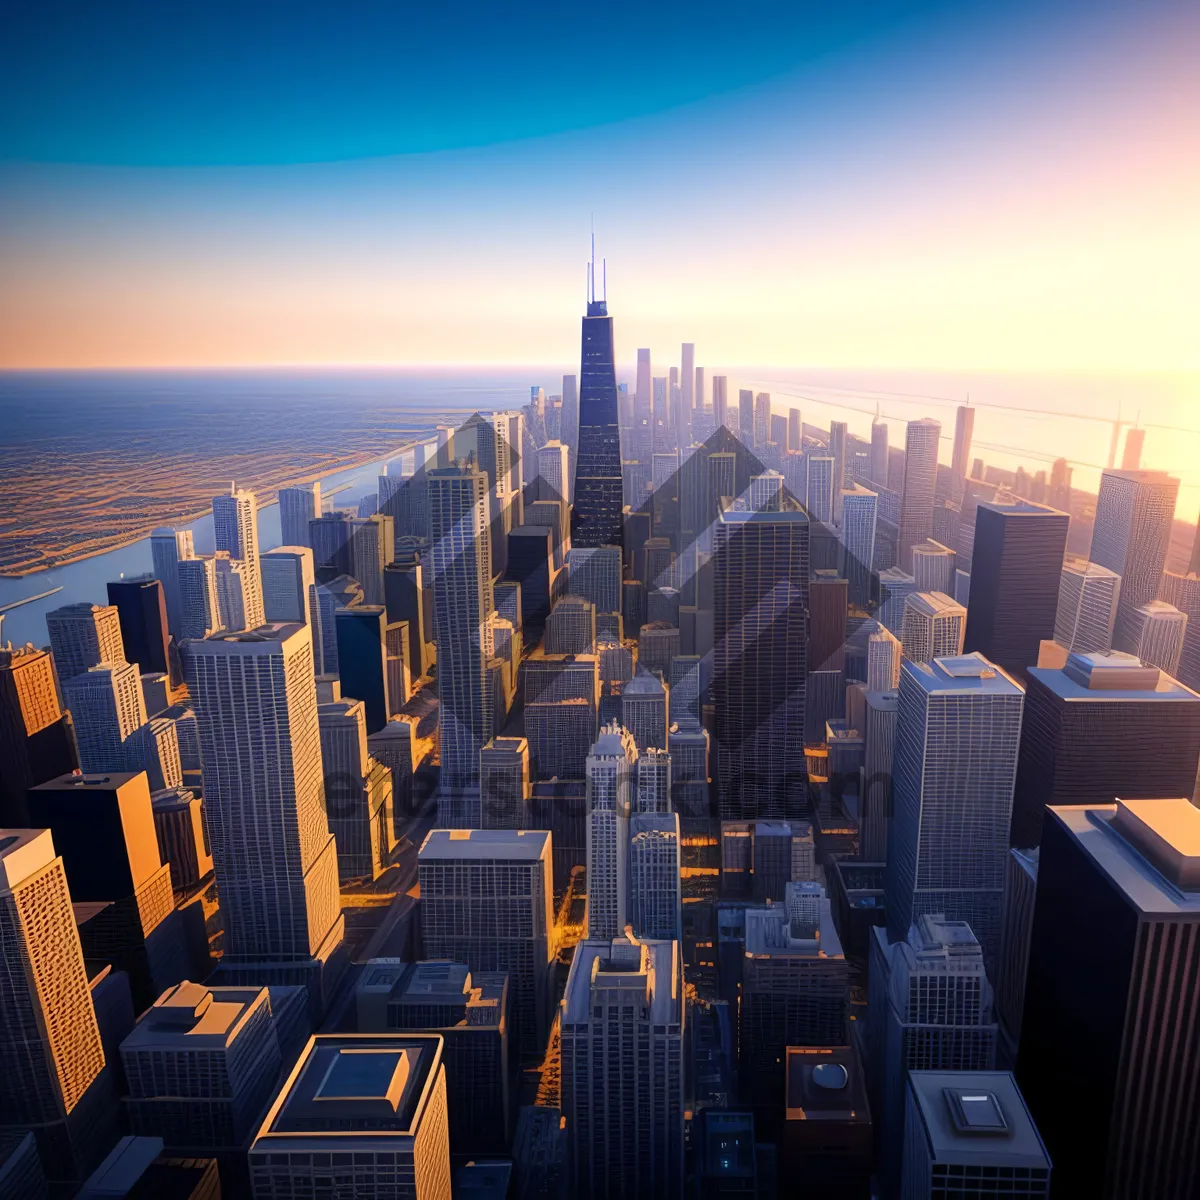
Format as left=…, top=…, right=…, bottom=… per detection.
left=419, top=829, right=556, bottom=1054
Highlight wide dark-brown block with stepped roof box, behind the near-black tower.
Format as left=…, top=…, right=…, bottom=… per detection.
left=1012, top=652, right=1200, bottom=850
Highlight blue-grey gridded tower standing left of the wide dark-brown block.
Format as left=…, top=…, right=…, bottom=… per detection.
left=887, top=654, right=1025, bottom=962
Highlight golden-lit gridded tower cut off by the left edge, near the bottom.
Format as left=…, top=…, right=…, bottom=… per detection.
left=0, top=829, right=115, bottom=1180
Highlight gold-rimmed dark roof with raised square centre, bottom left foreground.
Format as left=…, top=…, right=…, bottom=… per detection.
left=251, top=1033, right=444, bottom=1153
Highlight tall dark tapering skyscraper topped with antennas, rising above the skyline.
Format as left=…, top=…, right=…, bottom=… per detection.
left=571, top=254, right=622, bottom=547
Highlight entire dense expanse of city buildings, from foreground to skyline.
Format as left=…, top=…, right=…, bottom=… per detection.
left=0, top=263, right=1200, bottom=1200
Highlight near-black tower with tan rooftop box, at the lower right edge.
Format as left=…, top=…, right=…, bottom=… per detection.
left=1016, top=799, right=1200, bottom=1196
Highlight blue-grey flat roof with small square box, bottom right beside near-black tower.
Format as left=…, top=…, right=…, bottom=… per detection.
left=908, top=1070, right=1050, bottom=1170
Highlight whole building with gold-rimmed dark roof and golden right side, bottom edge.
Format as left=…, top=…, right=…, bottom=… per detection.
left=250, top=1033, right=450, bottom=1200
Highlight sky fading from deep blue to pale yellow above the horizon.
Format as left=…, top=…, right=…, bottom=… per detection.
left=0, top=0, right=1200, bottom=369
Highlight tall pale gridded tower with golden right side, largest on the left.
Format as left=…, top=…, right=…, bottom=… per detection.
left=187, top=624, right=344, bottom=1009
